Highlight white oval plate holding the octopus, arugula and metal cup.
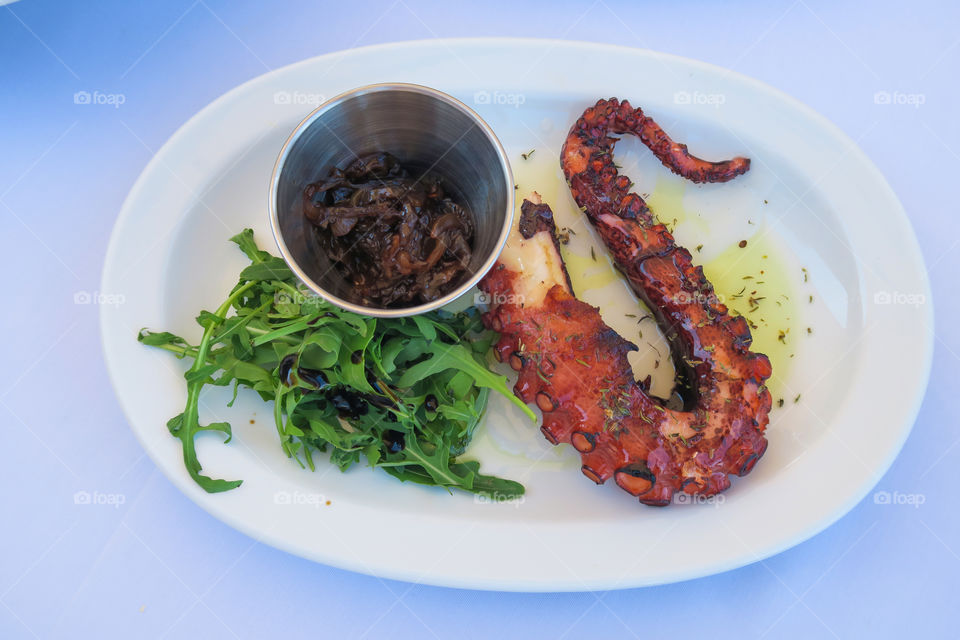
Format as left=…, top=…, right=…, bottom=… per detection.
left=101, top=39, right=933, bottom=591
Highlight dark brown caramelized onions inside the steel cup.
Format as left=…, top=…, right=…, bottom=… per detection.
left=303, top=153, right=474, bottom=307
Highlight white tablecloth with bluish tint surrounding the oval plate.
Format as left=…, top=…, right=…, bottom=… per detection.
left=0, top=0, right=960, bottom=638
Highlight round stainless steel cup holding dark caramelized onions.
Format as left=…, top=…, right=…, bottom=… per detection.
left=270, top=84, right=514, bottom=317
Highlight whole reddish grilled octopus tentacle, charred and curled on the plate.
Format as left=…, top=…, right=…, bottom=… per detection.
left=480, top=98, right=771, bottom=506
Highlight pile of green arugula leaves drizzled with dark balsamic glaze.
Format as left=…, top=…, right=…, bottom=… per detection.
left=138, top=229, right=535, bottom=496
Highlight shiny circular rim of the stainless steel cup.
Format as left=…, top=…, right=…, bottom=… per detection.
left=268, top=82, right=516, bottom=318
